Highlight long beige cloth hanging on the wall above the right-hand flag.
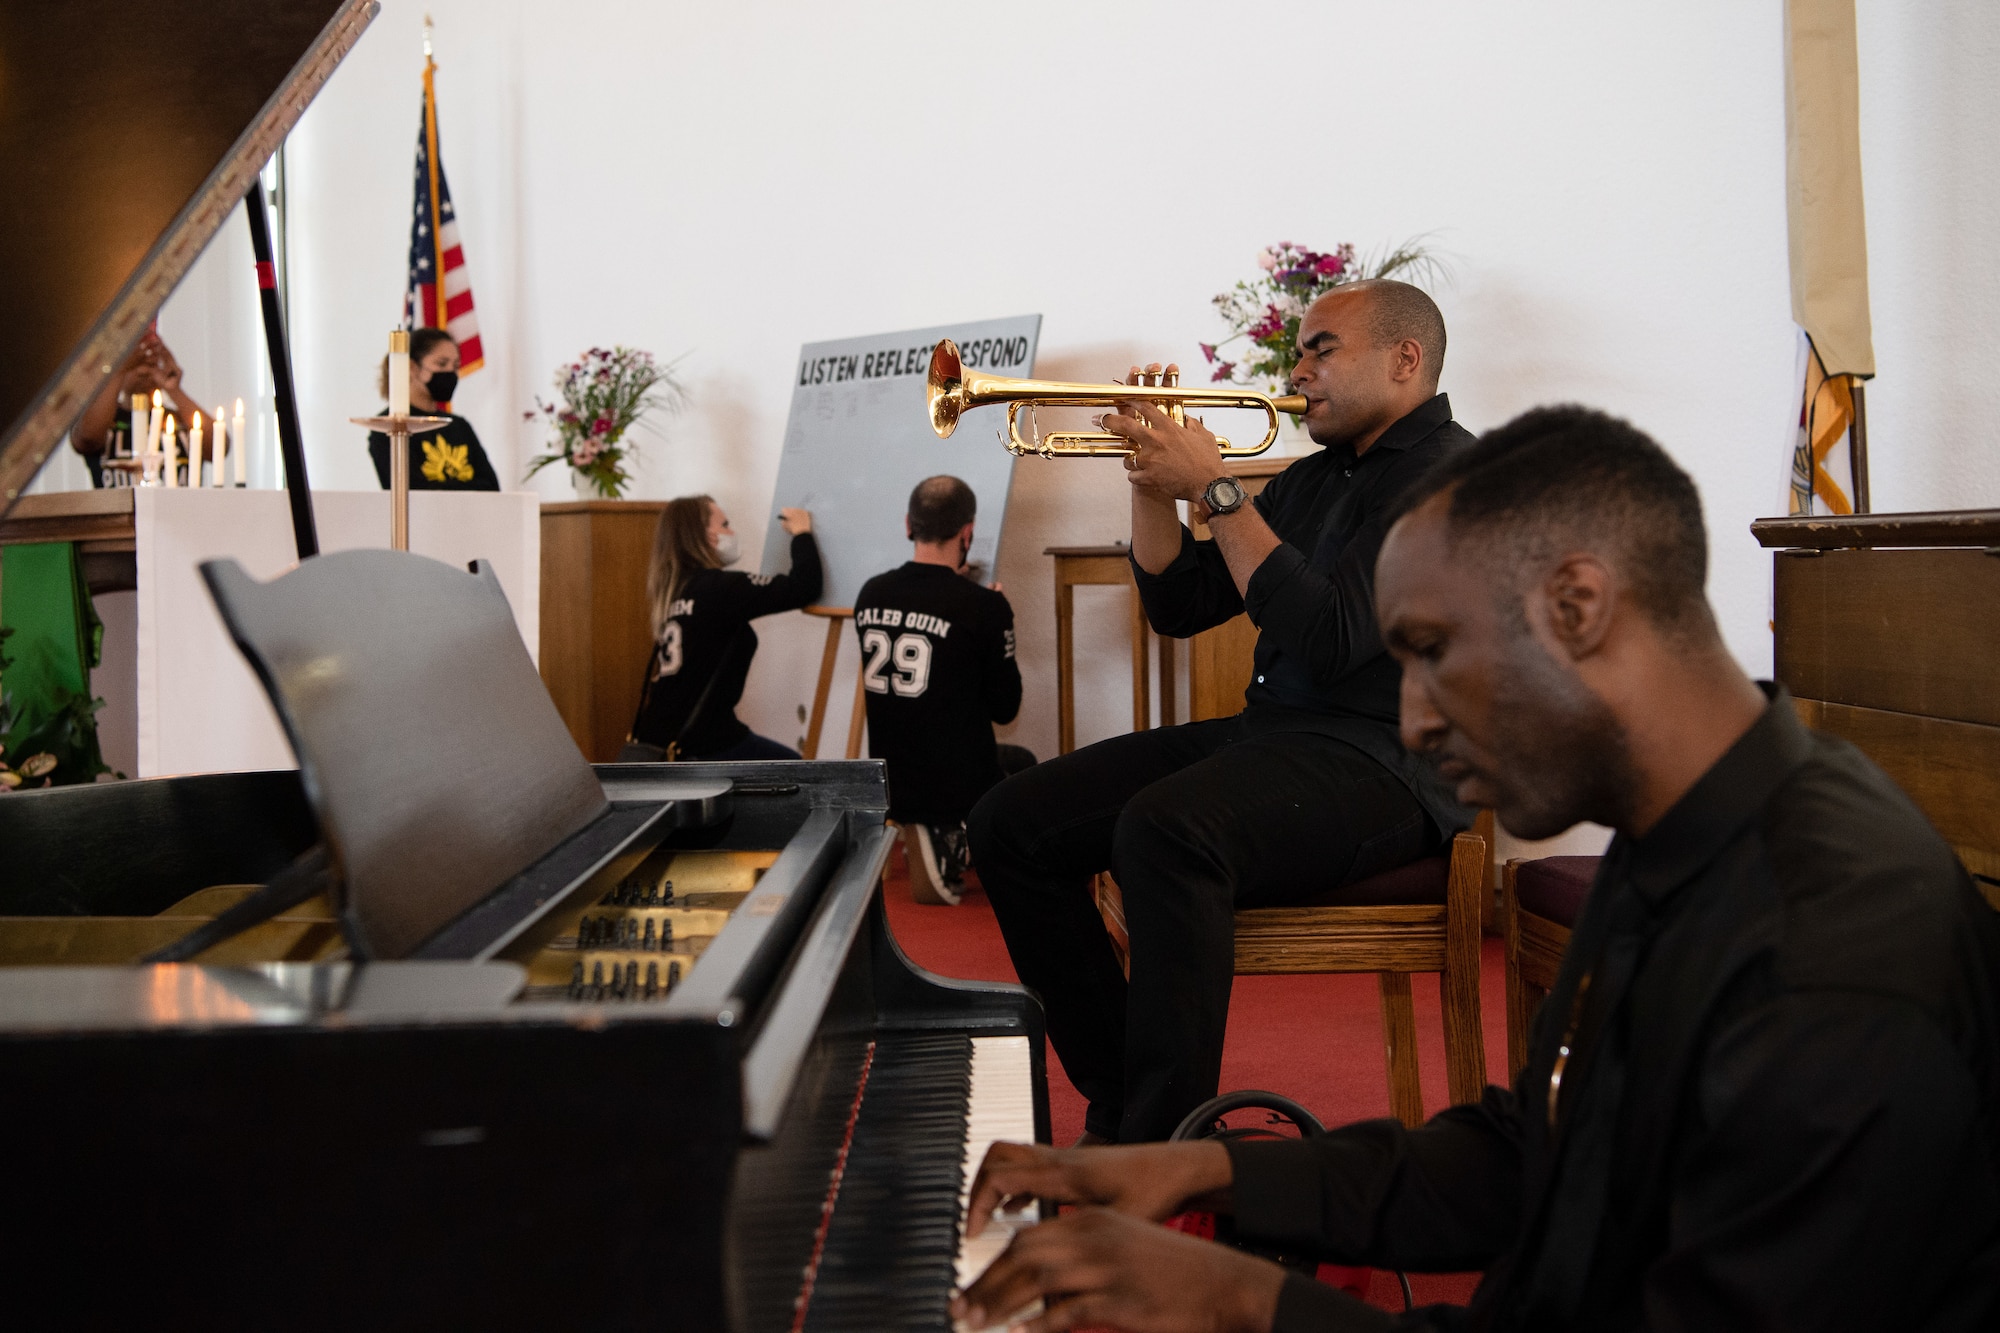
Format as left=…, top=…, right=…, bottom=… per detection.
left=1784, top=0, right=1874, bottom=378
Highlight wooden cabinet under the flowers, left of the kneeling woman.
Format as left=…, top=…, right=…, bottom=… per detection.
left=540, top=500, right=666, bottom=765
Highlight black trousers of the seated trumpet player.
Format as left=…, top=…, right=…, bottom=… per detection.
left=968, top=711, right=1440, bottom=1143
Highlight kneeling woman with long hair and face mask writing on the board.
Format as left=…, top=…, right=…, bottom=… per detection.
left=632, top=494, right=820, bottom=759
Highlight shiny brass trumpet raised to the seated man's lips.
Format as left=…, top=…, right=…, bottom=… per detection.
left=926, top=338, right=1306, bottom=458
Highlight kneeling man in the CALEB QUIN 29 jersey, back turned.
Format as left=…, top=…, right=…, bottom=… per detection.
left=854, top=476, right=1034, bottom=907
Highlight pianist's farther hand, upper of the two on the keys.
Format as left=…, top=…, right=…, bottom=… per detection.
left=966, top=1139, right=1234, bottom=1232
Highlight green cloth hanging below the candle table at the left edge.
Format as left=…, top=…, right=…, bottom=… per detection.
left=0, top=542, right=106, bottom=785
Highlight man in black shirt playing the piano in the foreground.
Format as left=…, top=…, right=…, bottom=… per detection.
left=966, top=408, right=2000, bottom=1333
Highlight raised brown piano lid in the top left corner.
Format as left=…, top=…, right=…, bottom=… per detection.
left=0, top=0, right=380, bottom=516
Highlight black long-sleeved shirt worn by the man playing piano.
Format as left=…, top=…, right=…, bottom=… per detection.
left=1230, top=689, right=2000, bottom=1333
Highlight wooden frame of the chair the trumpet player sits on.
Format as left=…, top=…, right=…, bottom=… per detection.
left=1096, top=815, right=1492, bottom=1125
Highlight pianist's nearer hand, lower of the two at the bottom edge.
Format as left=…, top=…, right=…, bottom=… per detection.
left=952, top=1200, right=1284, bottom=1333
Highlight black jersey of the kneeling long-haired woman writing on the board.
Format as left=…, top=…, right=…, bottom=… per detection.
left=632, top=532, right=820, bottom=759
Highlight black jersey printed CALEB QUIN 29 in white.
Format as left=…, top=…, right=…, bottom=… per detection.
left=854, top=560, right=1020, bottom=825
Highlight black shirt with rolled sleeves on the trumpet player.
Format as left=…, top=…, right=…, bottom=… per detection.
left=1132, top=394, right=1472, bottom=833
